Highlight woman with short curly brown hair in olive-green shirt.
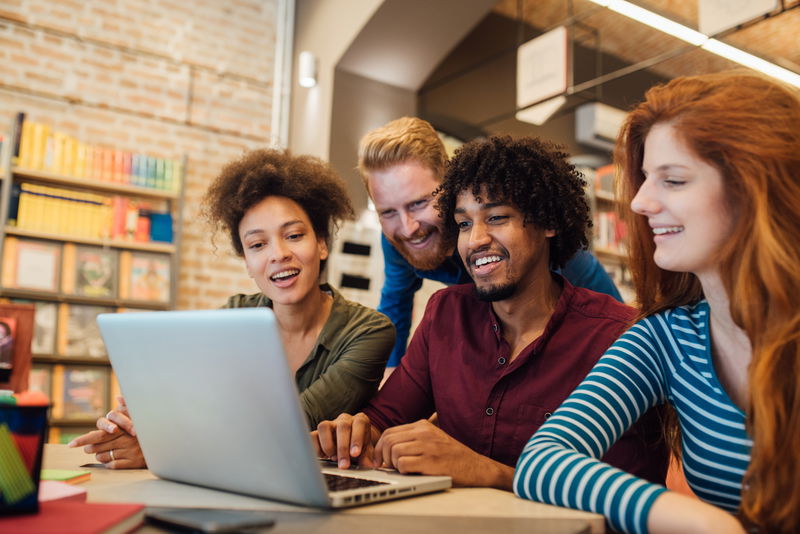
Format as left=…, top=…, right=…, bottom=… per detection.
left=70, top=150, right=394, bottom=468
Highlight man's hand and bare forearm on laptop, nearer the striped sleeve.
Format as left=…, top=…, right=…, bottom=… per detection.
left=375, top=420, right=514, bottom=490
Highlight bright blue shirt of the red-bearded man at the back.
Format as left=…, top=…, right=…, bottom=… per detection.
left=378, top=234, right=622, bottom=367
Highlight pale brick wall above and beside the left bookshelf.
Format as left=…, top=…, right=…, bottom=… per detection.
left=0, top=0, right=277, bottom=309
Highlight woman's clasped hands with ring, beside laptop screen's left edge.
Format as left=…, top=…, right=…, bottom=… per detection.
left=69, top=397, right=147, bottom=469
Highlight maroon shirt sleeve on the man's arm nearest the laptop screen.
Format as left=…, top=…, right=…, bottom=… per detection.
left=364, top=294, right=438, bottom=432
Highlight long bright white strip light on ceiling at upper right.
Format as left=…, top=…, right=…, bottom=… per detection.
left=591, top=0, right=800, bottom=87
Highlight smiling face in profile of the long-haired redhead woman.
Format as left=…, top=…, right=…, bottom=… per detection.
left=631, top=123, right=733, bottom=275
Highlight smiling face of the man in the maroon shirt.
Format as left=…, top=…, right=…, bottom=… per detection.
left=454, top=191, right=555, bottom=302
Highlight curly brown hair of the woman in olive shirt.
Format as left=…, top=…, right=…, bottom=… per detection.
left=203, top=149, right=353, bottom=256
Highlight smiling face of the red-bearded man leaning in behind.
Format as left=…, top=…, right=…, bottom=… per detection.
left=367, top=161, right=453, bottom=270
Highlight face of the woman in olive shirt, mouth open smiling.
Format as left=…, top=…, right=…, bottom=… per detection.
left=239, top=196, right=328, bottom=305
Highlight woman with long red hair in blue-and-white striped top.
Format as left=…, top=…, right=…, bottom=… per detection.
left=514, top=72, right=800, bottom=533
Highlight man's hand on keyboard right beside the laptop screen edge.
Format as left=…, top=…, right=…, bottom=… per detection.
left=311, top=413, right=380, bottom=469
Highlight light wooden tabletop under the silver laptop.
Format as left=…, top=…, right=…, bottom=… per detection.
left=44, top=444, right=605, bottom=534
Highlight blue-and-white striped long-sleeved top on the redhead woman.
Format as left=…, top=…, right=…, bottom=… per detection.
left=514, top=300, right=753, bottom=532
